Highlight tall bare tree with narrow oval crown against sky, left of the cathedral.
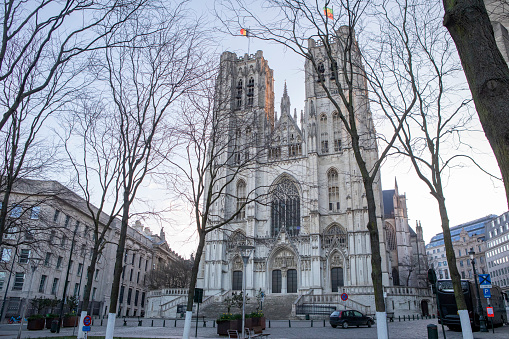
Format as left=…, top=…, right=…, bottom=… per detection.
left=83, top=4, right=210, bottom=338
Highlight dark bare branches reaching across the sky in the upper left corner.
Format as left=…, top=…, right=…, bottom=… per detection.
left=0, top=0, right=145, bottom=130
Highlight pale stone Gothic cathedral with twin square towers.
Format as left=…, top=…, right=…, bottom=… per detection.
left=198, top=29, right=426, bottom=312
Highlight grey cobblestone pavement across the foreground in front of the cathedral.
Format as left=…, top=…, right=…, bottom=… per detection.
left=0, top=319, right=509, bottom=339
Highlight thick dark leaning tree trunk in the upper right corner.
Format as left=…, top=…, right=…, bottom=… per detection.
left=443, top=0, right=509, bottom=207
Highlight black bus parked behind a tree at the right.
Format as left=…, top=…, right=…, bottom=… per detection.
left=437, top=280, right=507, bottom=331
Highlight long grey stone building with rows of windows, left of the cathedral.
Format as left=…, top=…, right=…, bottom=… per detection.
left=0, top=180, right=178, bottom=317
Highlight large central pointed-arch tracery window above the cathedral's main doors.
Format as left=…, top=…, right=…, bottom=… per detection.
left=271, top=178, right=300, bottom=236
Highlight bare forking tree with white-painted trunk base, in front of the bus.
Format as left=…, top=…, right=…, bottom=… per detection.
left=370, top=1, right=492, bottom=338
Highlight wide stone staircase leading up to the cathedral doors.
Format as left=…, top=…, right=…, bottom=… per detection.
left=196, top=295, right=298, bottom=320
